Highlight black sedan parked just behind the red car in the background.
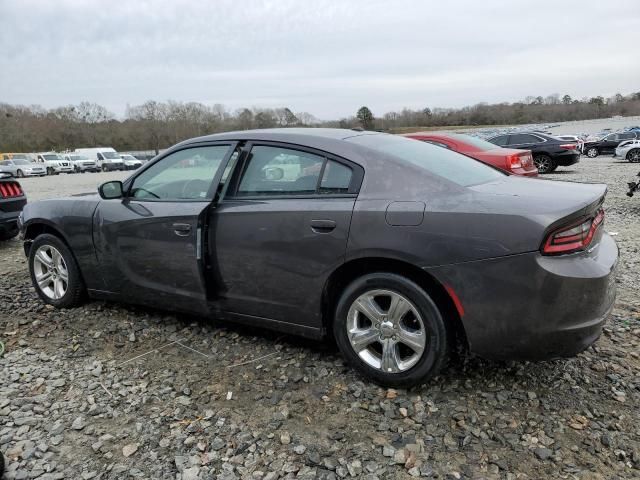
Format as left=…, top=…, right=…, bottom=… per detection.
left=488, top=132, right=580, bottom=173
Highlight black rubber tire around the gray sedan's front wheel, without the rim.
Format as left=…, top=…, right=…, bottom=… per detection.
left=29, top=233, right=86, bottom=308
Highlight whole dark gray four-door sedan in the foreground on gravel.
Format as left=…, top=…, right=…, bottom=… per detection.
left=21, top=129, right=618, bottom=386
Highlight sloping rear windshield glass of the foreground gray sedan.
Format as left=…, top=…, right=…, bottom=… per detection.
left=347, top=134, right=506, bottom=187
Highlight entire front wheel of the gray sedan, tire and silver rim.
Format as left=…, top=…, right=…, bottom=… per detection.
left=29, top=234, right=85, bottom=308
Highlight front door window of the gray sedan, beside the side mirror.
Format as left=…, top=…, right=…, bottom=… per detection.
left=129, top=145, right=229, bottom=201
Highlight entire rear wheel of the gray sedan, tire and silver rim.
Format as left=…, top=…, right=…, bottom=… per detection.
left=333, top=272, right=448, bottom=387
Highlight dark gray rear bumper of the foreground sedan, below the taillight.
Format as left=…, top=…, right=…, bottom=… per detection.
left=429, top=234, right=618, bottom=360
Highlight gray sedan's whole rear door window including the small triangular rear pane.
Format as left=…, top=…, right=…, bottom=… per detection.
left=236, top=145, right=352, bottom=197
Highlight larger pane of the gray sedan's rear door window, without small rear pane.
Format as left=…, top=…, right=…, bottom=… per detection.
left=237, top=145, right=325, bottom=196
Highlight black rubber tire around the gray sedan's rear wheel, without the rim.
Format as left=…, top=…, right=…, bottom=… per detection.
left=333, top=272, right=449, bottom=388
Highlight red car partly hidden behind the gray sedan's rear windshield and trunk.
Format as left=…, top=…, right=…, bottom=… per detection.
left=404, top=132, right=538, bottom=177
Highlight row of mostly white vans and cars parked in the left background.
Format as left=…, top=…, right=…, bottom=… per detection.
left=0, top=147, right=148, bottom=177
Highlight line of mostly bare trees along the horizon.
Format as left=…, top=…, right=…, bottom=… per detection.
left=0, top=92, right=640, bottom=152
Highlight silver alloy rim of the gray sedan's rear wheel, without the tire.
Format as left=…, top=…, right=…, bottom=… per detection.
left=346, top=290, right=427, bottom=373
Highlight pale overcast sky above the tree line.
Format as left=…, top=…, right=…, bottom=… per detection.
left=0, top=0, right=640, bottom=119
